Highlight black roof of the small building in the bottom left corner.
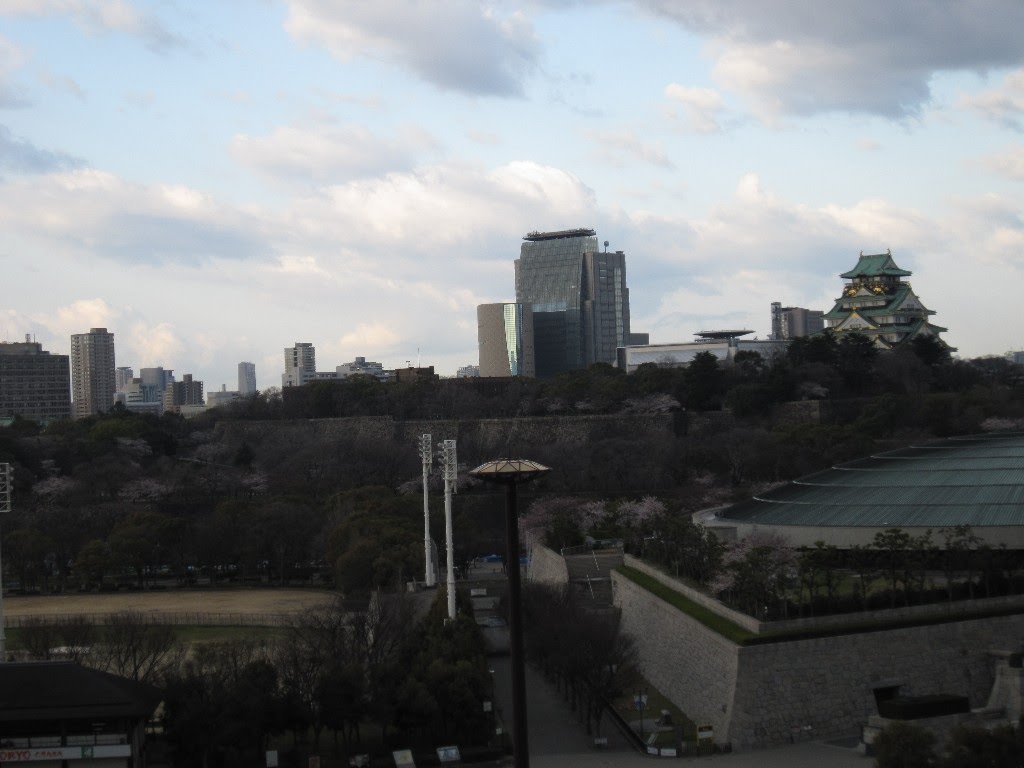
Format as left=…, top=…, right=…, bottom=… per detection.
left=0, top=662, right=162, bottom=722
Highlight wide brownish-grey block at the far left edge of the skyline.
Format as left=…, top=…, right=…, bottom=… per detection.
left=0, top=338, right=71, bottom=422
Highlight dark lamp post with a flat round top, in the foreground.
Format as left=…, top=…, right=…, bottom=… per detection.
left=470, top=459, right=551, bottom=768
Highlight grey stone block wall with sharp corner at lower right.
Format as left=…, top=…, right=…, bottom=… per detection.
left=612, top=573, right=1024, bottom=749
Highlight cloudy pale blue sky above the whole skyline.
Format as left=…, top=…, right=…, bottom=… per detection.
left=0, top=0, right=1024, bottom=391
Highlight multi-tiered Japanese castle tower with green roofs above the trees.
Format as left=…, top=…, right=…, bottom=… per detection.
left=824, top=251, right=946, bottom=349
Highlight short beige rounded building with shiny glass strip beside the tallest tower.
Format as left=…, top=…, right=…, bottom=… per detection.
left=476, top=303, right=537, bottom=377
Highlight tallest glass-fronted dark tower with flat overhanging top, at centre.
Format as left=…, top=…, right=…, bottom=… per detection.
left=515, top=229, right=630, bottom=378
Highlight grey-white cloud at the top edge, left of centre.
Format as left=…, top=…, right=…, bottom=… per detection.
left=286, top=0, right=538, bottom=96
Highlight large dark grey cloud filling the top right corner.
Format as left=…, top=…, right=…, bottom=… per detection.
left=636, top=0, right=1024, bottom=122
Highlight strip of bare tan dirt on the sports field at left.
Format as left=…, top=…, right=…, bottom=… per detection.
left=3, top=589, right=336, bottom=617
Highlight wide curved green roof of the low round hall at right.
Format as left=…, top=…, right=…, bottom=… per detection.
left=718, top=432, right=1024, bottom=530
